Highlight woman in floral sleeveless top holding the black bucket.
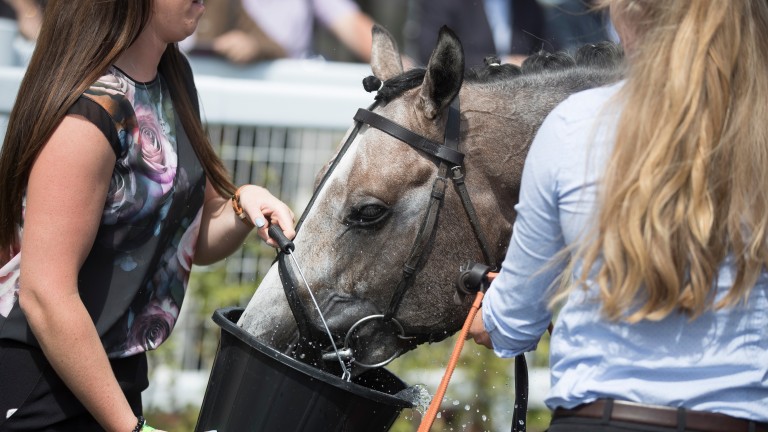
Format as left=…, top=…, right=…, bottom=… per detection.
left=0, top=0, right=295, bottom=432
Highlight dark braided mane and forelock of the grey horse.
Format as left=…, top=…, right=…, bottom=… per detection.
left=363, top=42, right=624, bottom=103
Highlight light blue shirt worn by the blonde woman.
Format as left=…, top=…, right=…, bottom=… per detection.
left=482, top=83, right=768, bottom=422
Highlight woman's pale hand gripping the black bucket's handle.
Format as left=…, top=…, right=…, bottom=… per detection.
left=240, top=185, right=296, bottom=247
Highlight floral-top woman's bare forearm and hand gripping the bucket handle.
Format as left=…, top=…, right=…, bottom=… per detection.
left=195, top=182, right=296, bottom=265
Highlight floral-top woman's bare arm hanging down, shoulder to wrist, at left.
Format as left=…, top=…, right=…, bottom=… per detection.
left=19, top=116, right=142, bottom=431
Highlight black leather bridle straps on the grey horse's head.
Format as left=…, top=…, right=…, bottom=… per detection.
left=277, top=87, right=528, bottom=432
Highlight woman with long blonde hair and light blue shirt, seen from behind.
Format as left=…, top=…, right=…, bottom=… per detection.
left=471, top=0, right=768, bottom=432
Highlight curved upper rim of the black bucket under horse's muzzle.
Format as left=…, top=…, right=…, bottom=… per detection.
left=212, top=306, right=415, bottom=408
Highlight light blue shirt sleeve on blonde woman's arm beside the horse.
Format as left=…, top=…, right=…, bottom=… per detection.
left=481, top=104, right=567, bottom=357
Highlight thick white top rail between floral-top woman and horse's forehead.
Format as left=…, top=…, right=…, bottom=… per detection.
left=191, top=57, right=373, bottom=130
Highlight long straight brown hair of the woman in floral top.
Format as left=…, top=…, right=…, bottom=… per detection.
left=0, top=0, right=234, bottom=265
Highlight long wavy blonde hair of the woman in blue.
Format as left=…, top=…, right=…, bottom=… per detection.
left=572, top=0, right=768, bottom=322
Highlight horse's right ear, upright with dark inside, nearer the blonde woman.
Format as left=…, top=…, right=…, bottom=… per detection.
left=420, top=26, right=464, bottom=119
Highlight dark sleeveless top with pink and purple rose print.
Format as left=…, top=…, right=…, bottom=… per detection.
left=0, top=67, right=205, bottom=358
